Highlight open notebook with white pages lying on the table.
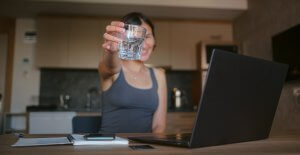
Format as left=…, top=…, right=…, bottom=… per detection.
left=11, top=134, right=128, bottom=147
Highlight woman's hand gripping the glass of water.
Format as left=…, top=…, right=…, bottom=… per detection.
left=102, top=21, right=125, bottom=53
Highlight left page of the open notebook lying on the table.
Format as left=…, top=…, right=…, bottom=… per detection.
left=12, top=137, right=72, bottom=147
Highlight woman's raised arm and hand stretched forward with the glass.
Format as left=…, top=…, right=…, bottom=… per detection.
left=98, top=21, right=125, bottom=80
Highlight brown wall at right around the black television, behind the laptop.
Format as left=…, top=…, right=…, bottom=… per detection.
left=233, top=0, right=300, bottom=134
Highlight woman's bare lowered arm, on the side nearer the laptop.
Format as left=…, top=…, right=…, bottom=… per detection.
left=152, top=69, right=167, bottom=133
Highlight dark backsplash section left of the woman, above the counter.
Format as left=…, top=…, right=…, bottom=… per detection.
left=40, top=69, right=101, bottom=110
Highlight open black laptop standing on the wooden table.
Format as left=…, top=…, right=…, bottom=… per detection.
left=129, top=49, right=288, bottom=148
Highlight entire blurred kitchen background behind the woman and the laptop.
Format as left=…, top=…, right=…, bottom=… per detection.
left=0, top=0, right=300, bottom=133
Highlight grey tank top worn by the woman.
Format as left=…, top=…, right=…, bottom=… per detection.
left=100, top=68, right=159, bottom=133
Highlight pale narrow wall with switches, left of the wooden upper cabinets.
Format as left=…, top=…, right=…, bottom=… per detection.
left=11, top=18, right=40, bottom=129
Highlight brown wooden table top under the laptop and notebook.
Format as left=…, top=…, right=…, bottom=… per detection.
left=0, top=133, right=300, bottom=155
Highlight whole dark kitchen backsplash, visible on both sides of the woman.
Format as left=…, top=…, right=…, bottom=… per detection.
left=40, top=69, right=196, bottom=111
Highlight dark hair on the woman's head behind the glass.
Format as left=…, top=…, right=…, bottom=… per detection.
left=122, top=12, right=155, bottom=37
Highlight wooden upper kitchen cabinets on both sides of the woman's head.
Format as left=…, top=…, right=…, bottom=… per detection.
left=36, top=17, right=232, bottom=70
